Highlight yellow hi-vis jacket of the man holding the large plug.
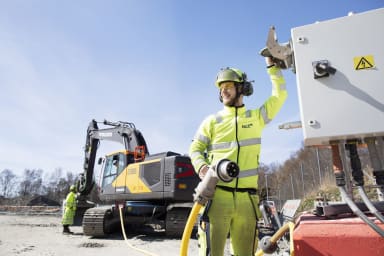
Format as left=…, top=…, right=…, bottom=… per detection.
left=189, top=66, right=288, bottom=188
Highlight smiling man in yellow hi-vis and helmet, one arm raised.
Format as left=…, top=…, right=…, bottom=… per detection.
left=189, top=57, right=287, bottom=256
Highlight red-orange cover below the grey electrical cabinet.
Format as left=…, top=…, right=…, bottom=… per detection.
left=293, top=214, right=384, bottom=256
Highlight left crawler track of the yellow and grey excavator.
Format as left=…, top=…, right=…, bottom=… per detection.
left=83, top=208, right=108, bottom=237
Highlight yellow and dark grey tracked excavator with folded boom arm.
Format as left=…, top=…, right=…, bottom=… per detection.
left=74, top=120, right=200, bottom=237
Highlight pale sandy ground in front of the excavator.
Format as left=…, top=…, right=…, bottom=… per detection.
left=0, top=214, right=206, bottom=256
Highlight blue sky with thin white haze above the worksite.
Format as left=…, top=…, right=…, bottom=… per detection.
left=0, top=0, right=384, bottom=174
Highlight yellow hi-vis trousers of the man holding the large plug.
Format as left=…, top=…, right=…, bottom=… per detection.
left=198, top=188, right=260, bottom=256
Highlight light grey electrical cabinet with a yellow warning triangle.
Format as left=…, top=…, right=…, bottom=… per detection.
left=291, top=8, right=384, bottom=146
